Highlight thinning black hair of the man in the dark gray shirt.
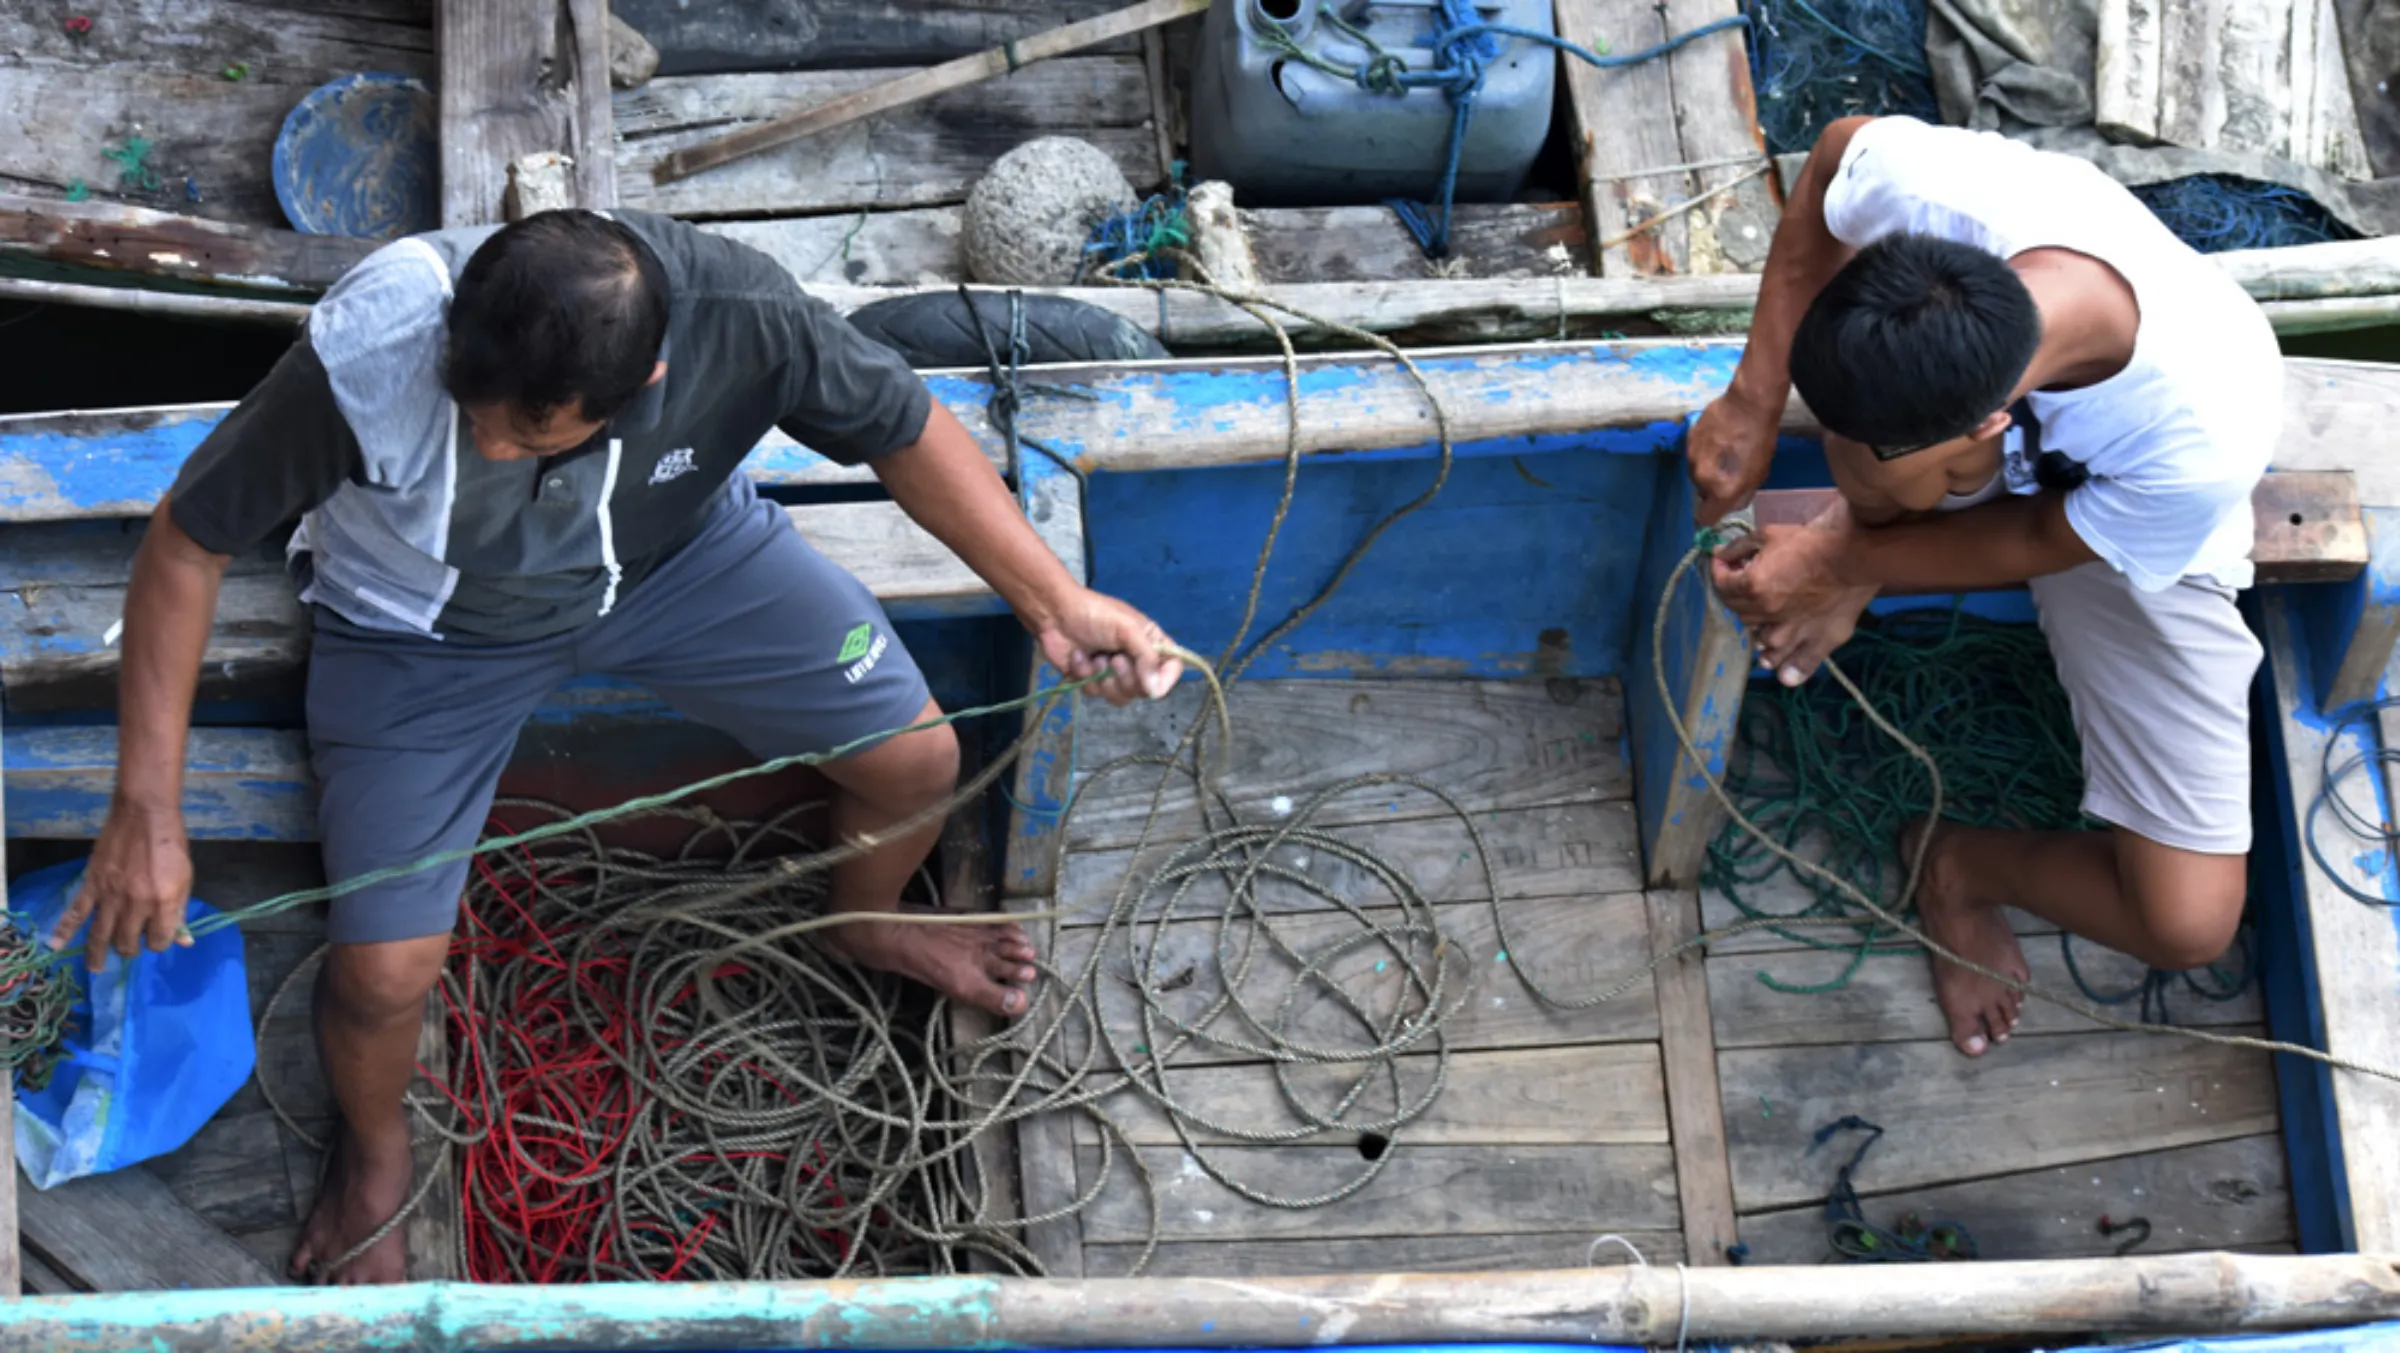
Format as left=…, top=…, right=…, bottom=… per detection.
left=442, top=211, right=667, bottom=422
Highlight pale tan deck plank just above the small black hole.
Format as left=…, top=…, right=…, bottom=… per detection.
left=1073, top=1044, right=1668, bottom=1154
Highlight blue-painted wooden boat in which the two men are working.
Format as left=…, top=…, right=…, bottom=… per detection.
left=0, top=341, right=2400, bottom=1351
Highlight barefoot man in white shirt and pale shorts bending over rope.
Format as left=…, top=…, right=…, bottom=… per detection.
left=1690, top=118, right=2282, bottom=1056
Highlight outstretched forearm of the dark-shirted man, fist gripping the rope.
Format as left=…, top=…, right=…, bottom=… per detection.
left=874, top=401, right=1183, bottom=703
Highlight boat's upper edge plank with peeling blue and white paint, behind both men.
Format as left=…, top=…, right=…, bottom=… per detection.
left=18, top=352, right=2400, bottom=521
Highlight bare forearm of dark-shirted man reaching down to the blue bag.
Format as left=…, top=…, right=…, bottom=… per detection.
left=50, top=501, right=230, bottom=972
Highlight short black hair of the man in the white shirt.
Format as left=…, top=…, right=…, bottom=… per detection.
left=1793, top=235, right=2042, bottom=451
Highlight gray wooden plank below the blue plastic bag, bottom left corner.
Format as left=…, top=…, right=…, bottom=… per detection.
left=12, top=1166, right=276, bottom=1291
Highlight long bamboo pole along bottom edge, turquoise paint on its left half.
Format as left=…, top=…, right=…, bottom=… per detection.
left=0, top=1255, right=2400, bottom=1353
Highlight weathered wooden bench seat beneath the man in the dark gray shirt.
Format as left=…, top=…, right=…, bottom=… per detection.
left=0, top=501, right=1006, bottom=712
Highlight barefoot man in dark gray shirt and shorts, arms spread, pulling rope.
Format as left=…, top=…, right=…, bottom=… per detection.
left=53, top=211, right=1181, bottom=1283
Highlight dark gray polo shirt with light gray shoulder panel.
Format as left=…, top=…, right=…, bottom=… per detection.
left=168, top=211, right=931, bottom=643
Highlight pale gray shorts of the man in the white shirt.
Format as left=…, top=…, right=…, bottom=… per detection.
left=2030, top=554, right=2261, bottom=854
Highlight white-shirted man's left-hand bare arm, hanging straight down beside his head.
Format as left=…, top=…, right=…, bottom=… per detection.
left=1687, top=118, right=1872, bottom=525
